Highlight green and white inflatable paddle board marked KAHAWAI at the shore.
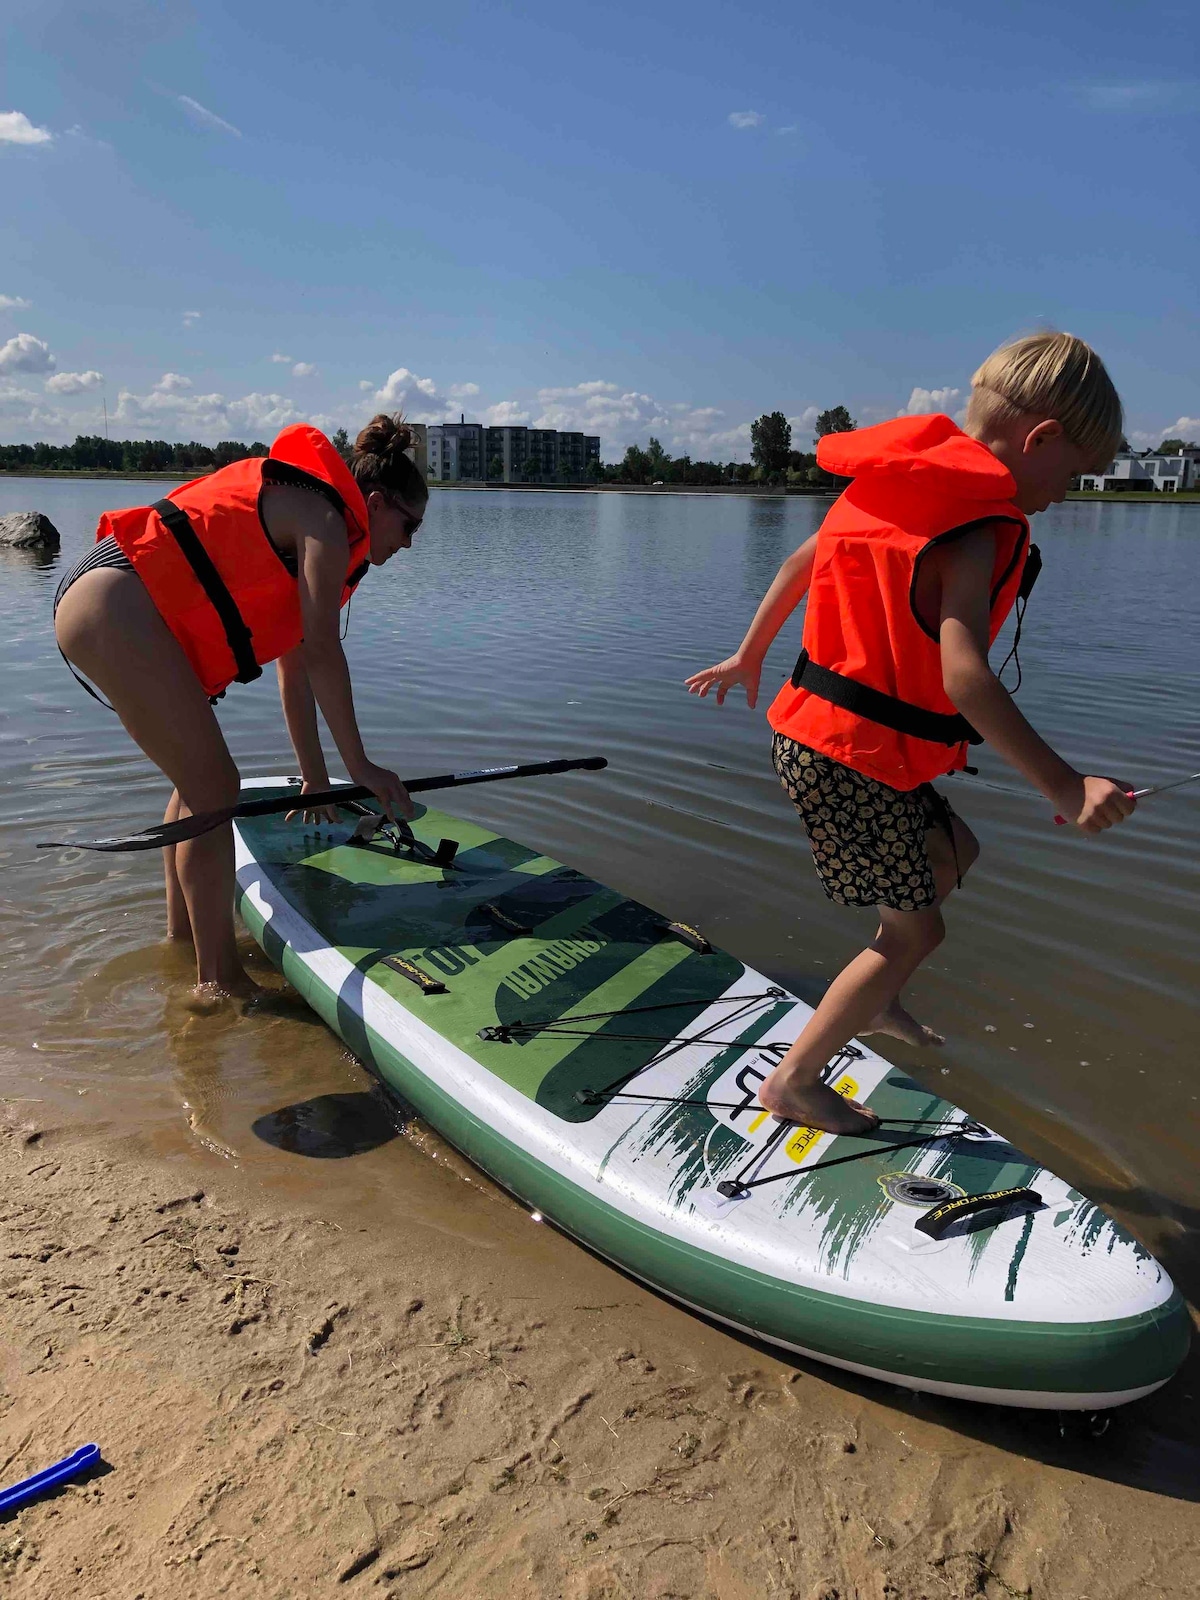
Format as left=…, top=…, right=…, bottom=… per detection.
left=235, top=778, right=1190, bottom=1410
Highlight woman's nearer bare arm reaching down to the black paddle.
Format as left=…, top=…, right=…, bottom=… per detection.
left=267, top=488, right=413, bottom=816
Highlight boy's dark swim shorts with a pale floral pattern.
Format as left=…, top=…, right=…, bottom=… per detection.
left=771, top=733, right=954, bottom=910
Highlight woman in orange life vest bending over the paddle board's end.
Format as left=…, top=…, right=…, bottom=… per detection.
left=54, top=416, right=429, bottom=995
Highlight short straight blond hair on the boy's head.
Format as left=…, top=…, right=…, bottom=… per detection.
left=966, top=331, right=1125, bottom=464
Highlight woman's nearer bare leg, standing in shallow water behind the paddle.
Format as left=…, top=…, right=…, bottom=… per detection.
left=56, top=568, right=246, bottom=989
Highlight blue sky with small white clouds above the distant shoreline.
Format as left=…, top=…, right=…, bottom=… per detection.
left=0, top=0, right=1200, bottom=459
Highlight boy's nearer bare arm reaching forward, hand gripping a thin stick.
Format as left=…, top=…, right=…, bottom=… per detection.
left=933, top=528, right=1136, bottom=834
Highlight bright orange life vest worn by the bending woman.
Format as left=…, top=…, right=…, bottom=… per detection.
left=96, top=422, right=370, bottom=698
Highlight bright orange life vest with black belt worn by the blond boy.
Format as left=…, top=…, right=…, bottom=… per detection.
left=766, top=416, right=1037, bottom=789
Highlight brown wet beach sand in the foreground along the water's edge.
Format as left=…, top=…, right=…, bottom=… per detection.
left=0, top=1102, right=1200, bottom=1600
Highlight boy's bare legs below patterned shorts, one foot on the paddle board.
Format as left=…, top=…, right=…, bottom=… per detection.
left=758, top=818, right=979, bottom=1133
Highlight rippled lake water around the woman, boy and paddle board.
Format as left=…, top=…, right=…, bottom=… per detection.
left=0, top=478, right=1200, bottom=1298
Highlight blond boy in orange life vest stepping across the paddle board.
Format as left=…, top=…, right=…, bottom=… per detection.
left=686, top=333, right=1134, bottom=1134
